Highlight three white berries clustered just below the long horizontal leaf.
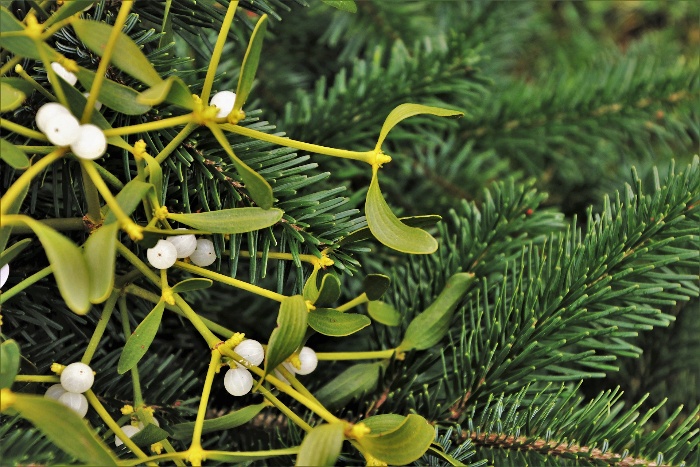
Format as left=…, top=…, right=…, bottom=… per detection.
left=146, top=229, right=216, bottom=269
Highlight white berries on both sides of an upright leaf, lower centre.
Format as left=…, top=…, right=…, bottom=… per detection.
left=224, top=339, right=318, bottom=396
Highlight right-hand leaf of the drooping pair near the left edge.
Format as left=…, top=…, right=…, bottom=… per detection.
left=83, top=222, right=119, bottom=303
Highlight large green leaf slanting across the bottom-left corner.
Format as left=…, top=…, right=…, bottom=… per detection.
left=6, top=393, right=117, bottom=465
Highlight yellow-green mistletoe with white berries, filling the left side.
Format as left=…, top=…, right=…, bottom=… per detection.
left=0, top=0, right=473, bottom=465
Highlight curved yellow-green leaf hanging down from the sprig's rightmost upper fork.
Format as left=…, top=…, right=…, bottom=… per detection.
left=365, top=169, right=438, bottom=255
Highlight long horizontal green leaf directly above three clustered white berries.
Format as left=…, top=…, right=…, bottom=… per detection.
left=168, top=207, right=284, bottom=234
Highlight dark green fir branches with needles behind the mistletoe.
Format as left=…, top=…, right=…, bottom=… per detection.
left=0, top=0, right=700, bottom=466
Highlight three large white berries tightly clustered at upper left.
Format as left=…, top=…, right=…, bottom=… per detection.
left=36, top=102, right=107, bottom=160
